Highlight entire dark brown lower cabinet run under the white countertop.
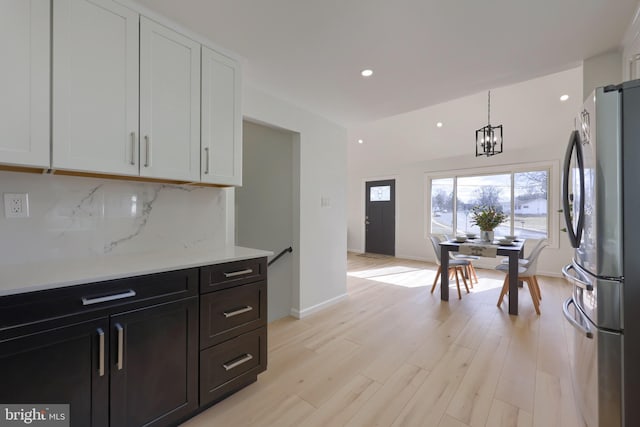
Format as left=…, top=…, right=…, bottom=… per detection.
left=0, top=257, right=267, bottom=427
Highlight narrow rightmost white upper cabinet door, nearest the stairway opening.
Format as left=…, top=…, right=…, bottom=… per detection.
left=201, top=46, right=242, bottom=185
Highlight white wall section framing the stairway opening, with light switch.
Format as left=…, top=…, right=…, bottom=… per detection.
left=243, top=87, right=347, bottom=317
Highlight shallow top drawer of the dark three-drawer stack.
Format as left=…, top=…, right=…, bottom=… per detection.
left=200, top=257, right=267, bottom=293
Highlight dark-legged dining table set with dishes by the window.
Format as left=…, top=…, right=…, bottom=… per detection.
left=440, top=239, right=524, bottom=316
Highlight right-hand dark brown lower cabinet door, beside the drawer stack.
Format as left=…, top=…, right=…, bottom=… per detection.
left=110, top=298, right=198, bottom=427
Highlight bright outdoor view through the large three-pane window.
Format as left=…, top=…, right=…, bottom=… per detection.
left=430, top=170, right=549, bottom=239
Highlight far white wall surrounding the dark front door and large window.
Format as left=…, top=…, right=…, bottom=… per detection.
left=347, top=67, right=582, bottom=275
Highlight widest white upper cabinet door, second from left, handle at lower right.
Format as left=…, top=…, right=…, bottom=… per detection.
left=52, top=0, right=139, bottom=175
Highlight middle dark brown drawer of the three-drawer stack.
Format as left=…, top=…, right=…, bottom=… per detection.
left=200, top=281, right=267, bottom=349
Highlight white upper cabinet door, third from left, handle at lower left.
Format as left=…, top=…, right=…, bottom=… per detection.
left=140, top=17, right=200, bottom=181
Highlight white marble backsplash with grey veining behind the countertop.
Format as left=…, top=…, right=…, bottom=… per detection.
left=0, top=172, right=231, bottom=265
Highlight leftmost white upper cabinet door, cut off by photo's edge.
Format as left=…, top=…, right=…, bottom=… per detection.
left=0, top=0, right=51, bottom=168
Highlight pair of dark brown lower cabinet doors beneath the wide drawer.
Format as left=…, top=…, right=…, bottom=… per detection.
left=0, top=297, right=199, bottom=427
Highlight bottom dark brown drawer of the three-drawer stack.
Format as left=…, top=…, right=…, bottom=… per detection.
left=200, top=326, right=267, bottom=406
